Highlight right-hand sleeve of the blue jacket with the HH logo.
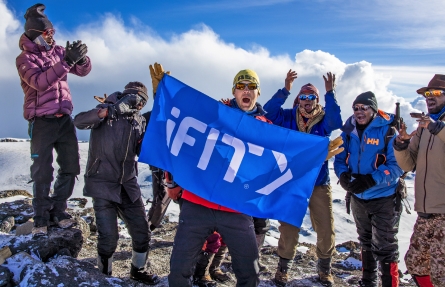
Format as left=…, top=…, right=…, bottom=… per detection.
left=372, top=137, right=403, bottom=185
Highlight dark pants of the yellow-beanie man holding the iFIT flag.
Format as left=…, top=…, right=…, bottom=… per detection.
left=168, top=200, right=260, bottom=287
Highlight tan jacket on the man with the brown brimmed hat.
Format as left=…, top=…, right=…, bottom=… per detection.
left=394, top=114, right=445, bottom=214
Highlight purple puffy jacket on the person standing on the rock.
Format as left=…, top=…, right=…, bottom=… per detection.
left=16, top=34, right=91, bottom=120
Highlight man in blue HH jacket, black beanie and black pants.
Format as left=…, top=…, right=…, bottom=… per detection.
left=334, top=92, right=402, bottom=287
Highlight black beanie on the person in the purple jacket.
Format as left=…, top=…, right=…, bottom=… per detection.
left=24, top=3, right=53, bottom=41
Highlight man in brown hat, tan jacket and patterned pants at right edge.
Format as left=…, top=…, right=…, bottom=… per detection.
left=394, top=75, right=445, bottom=287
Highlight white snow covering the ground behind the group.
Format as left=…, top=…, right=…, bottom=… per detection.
left=0, top=141, right=417, bottom=272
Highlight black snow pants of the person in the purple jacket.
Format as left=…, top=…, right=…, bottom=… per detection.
left=28, top=115, right=80, bottom=227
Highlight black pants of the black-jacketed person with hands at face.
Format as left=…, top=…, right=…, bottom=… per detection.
left=93, top=188, right=151, bottom=258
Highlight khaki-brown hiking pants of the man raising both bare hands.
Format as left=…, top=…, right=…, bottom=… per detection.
left=277, top=185, right=335, bottom=260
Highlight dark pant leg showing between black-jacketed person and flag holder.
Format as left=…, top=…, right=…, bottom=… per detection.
left=147, top=166, right=171, bottom=231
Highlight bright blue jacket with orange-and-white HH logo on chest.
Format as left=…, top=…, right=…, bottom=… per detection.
left=334, top=111, right=403, bottom=199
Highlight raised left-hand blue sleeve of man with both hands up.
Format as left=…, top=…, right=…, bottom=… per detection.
left=264, top=88, right=292, bottom=126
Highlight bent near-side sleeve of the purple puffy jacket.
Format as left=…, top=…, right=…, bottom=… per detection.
left=16, top=54, right=70, bottom=92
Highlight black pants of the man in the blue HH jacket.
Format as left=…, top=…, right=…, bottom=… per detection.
left=351, top=195, right=402, bottom=262
